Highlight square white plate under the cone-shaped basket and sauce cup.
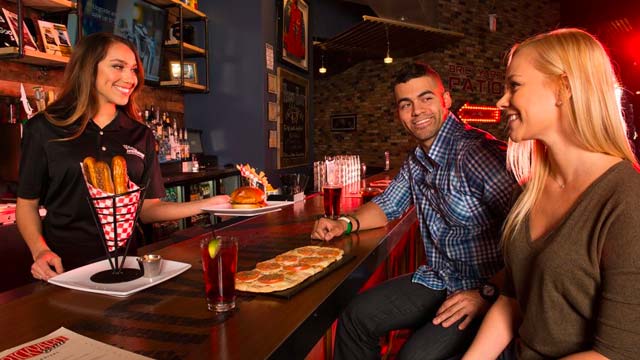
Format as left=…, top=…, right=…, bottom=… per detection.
left=49, top=256, right=191, bottom=297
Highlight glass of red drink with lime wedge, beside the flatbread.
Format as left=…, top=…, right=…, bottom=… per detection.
left=200, top=236, right=238, bottom=312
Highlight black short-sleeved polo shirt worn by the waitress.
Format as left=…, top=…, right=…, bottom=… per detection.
left=18, top=111, right=165, bottom=270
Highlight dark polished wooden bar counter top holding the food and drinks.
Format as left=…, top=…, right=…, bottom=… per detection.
left=0, top=173, right=417, bottom=360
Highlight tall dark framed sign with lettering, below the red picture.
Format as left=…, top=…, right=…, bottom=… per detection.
left=278, top=69, right=309, bottom=168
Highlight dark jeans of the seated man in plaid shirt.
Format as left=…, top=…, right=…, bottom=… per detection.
left=334, top=274, right=482, bottom=360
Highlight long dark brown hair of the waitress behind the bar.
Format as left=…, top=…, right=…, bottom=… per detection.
left=44, top=32, right=144, bottom=140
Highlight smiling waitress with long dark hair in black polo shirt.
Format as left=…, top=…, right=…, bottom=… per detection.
left=16, top=33, right=229, bottom=280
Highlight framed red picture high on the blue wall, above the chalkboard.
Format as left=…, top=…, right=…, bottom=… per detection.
left=277, top=0, right=309, bottom=71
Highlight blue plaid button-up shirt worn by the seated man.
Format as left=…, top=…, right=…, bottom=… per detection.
left=373, top=113, right=516, bottom=293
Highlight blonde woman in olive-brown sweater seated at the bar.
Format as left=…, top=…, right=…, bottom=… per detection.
left=464, top=29, right=640, bottom=359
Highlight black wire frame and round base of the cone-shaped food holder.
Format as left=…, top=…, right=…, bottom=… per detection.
left=87, top=187, right=146, bottom=284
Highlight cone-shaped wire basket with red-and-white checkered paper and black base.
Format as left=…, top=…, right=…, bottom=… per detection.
left=87, top=185, right=145, bottom=284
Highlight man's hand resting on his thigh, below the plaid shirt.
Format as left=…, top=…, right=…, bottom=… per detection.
left=433, top=289, right=491, bottom=330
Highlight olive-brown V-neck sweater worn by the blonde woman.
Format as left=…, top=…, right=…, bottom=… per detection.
left=504, top=161, right=640, bottom=359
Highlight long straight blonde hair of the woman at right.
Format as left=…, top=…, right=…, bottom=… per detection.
left=502, top=28, right=637, bottom=244
